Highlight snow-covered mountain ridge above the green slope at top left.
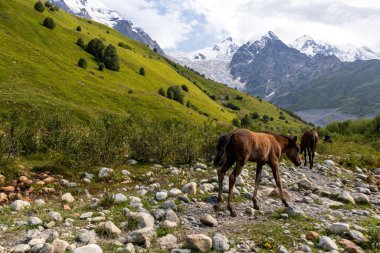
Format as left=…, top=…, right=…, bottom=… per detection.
left=51, top=0, right=165, bottom=55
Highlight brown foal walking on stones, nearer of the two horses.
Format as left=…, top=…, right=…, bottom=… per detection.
left=214, top=129, right=301, bottom=217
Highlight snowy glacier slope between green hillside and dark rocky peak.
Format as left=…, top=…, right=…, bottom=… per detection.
left=167, top=37, right=244, bottom=89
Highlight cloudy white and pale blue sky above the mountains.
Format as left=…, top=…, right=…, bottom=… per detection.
left=103, top=0, right=380, bottom=51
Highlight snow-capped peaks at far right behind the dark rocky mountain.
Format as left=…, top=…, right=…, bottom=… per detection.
left=289, top=35, right=380, bottom=62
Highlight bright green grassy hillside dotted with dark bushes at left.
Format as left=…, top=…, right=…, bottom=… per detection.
left=0, top=0, right=302, bottom=129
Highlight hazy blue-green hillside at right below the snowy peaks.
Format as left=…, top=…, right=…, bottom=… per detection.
left=276, top=60, right=380, bottom=116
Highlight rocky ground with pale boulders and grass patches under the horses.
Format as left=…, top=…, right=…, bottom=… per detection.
left=0, top=157, right=380, bottom=253
